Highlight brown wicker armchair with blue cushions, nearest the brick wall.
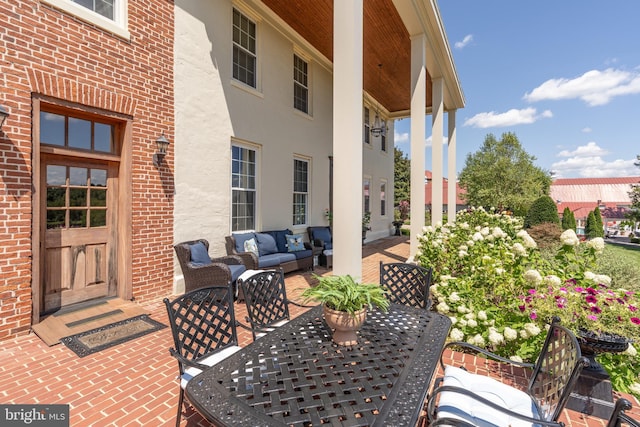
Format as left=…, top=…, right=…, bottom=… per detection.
left=173, top=239, right=246, bottom=294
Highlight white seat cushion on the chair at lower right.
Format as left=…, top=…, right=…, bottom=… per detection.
left=437, top=366, right=540, bottom=427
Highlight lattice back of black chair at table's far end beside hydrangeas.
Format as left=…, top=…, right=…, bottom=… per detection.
left=380, top=261, right=431, bottom=308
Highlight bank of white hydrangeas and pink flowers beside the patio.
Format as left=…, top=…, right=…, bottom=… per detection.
left=415, top=208, right=640, bottom=398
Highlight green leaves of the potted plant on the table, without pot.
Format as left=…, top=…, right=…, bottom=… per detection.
left=301, top=274, right=389, bottom=316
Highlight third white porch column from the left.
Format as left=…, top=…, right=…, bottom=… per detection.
left=431, top=77, right=444, bottom=225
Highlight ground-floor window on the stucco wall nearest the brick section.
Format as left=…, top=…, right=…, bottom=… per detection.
left=231, top=145, right=257, bottom=231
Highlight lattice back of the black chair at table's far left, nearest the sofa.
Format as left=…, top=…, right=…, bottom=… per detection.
left=238, top=269, right=290, bottom=339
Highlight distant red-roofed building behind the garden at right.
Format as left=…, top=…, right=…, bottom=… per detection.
left=549, top=176, right=640, bottom=233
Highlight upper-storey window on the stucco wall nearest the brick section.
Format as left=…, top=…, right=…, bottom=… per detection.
left=233, top=9, right=258, bottom=88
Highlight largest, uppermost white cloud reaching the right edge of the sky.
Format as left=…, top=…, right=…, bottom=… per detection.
left=524, top=68, right=640, bottom=106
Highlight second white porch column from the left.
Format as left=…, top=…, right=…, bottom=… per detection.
left=409, top=34, right=427, bottom=258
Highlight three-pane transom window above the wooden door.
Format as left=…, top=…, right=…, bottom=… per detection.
left=40, top=111, right=115, bottom=153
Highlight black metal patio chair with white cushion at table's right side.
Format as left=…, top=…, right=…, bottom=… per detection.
left=427, top=322, right=589, bottom=427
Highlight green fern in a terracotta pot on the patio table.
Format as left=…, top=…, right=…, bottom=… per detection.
left=302, top=274, right=389, bottom=345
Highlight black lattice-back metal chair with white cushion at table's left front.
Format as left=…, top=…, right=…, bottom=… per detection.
left=163, top=285, right=240, bottom=427
